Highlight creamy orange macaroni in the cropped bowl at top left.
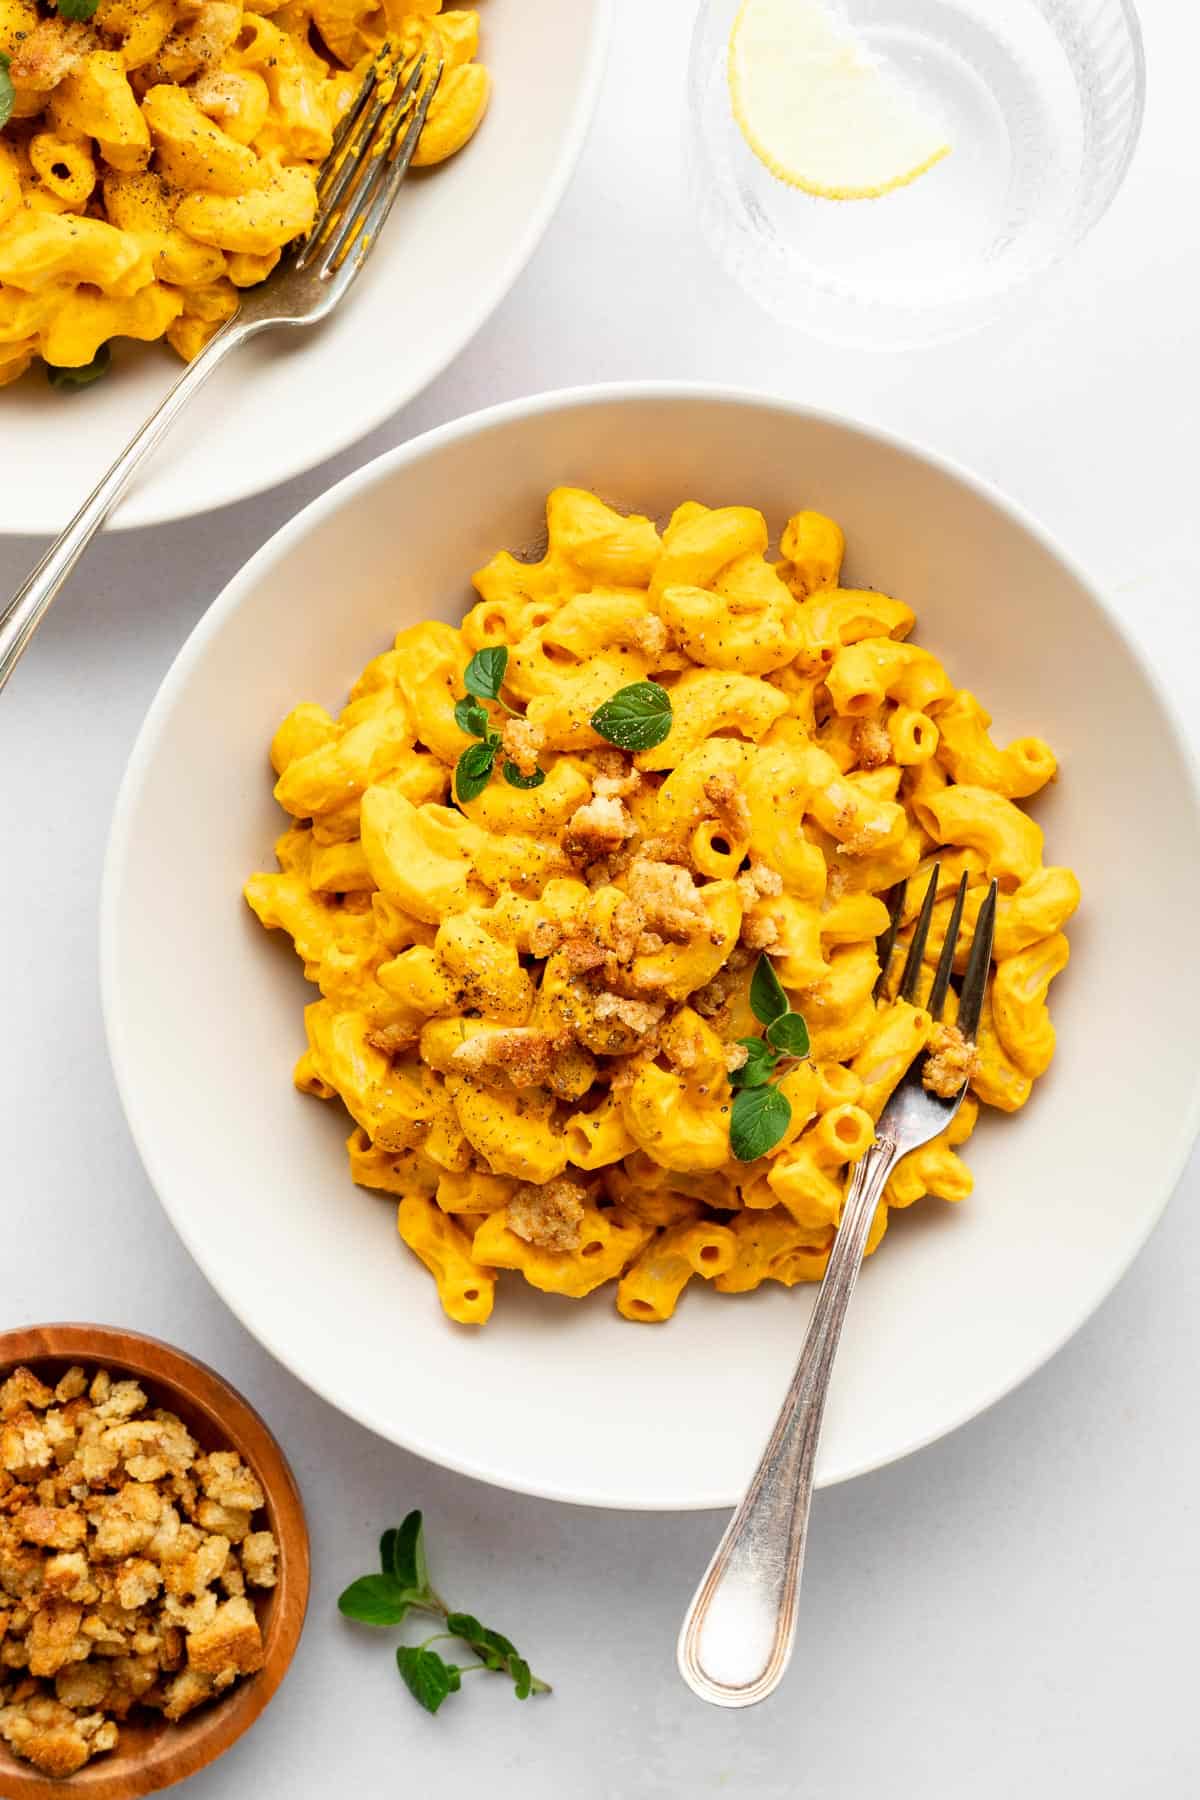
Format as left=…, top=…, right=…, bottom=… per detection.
left=0, top=0, right=489, bottom=385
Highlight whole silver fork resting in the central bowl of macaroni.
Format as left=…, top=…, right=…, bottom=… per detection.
left=676, top=868, right=997, bottom=1706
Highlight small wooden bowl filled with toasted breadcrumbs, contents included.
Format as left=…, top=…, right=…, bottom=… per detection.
left=0, top=1325, right=309, bottom=1800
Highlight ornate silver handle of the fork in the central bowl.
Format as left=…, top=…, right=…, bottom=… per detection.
left=676, top=1138, right=896, bottom=1706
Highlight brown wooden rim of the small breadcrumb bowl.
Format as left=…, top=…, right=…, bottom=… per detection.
left=0, top=1321, right=311, bottom=1800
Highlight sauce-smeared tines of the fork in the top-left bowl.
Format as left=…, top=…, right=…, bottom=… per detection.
left=293, top=43, right=443, bottom=281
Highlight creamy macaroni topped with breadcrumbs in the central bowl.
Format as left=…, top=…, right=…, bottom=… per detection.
left=244, top=486, right=1079, bottom=1323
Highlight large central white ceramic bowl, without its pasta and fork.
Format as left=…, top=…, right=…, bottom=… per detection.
left=103, top=387, right=1200, bottom=1508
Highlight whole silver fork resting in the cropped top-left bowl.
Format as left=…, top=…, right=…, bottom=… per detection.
left=0, top=45, right=443, bottom=689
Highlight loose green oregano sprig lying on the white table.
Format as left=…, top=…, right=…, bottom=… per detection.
left=338, top=1512, right=551, bottom=1712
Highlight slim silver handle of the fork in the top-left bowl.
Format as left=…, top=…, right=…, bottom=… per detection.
left=0, top=313, right=243, bottom=689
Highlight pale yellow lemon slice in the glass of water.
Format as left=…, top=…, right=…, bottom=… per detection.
left=729, top=0, right=950, bottom=200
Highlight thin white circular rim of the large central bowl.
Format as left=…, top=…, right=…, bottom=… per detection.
left=99, top=380, right=1200, bottom=1512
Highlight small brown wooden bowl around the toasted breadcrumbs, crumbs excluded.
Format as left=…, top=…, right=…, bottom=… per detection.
left=0, top=1325, right=309, bottom=1800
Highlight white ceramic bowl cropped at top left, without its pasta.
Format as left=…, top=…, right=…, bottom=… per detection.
left=0, top=0, right=612, bottom=533
